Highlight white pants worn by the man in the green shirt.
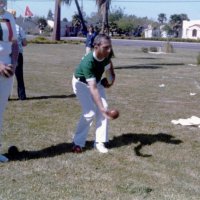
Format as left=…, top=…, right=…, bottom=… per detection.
left=72, top=76, right=108, bottom=147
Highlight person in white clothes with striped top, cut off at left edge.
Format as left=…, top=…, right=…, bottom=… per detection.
left=0, top=0, right=18, bottom=162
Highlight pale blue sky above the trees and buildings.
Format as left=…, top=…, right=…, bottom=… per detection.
left=7, top=0, right=200, bottom=21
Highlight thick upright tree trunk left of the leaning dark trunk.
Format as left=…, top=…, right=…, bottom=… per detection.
left=52, top=0, right=61, bottom=40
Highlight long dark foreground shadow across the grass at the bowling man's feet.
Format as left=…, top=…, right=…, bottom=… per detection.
left=5, top=133, right=182, bottom=161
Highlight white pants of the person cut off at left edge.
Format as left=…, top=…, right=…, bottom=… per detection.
left=0, top=76, right=13, bottom=145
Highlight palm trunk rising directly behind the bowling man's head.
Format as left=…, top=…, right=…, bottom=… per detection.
left=96, top=0, right=111, bottom=34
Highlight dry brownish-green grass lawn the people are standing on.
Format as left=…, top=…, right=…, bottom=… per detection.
left=0, top=41, right=200, bottom=200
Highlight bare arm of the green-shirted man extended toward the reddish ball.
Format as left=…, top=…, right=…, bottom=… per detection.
left=88, top=80, right=110, bottom=119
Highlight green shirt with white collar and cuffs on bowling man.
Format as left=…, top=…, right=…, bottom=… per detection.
left=74, top=52, right=111, bottom=83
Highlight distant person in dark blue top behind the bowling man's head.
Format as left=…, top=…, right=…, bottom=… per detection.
left=85, top=25, right=97, bottom=54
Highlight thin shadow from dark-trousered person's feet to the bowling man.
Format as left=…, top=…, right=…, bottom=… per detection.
left=9, top=94, right=76, bottom=101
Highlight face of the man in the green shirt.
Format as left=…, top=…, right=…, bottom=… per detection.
left=97, top=39, right=112, bottom=58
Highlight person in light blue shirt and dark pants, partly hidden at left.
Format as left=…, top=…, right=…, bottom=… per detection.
left=8, top=10, right=27, bottom=100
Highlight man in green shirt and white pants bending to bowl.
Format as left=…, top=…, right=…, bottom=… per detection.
left=72, top=34, right=115, bottom=153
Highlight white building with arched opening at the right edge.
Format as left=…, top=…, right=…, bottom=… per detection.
left=182, top=20, right=200, bottom=39
